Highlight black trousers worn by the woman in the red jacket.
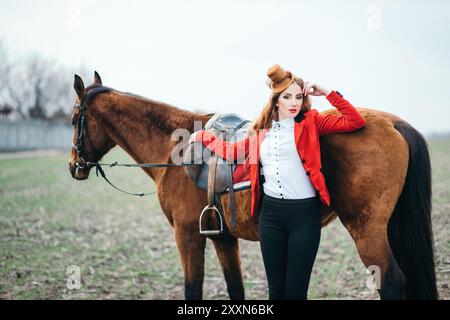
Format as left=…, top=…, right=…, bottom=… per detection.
left=259, top=194, right=321, bottom=300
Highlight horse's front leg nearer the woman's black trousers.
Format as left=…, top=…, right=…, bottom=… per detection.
left=211, top=235, right=245, bottom=300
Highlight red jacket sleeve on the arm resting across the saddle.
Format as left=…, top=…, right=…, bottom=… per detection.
left=194, top=130, right=250, bottom=160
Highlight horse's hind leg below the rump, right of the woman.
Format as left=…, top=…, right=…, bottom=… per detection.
left=341, top=212, right=405, bottom=300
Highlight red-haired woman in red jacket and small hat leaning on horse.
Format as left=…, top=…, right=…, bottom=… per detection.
left=191, top=65, right=366, bottom=299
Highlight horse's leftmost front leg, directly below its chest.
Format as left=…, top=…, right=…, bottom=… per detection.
left=174, top=226, right=206, bottom=300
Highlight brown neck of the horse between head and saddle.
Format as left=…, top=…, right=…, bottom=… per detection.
left=93, top=92, right=207, bottom=183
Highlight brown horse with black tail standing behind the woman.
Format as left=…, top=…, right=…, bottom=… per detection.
left=69, top=73, right=437, bottom=299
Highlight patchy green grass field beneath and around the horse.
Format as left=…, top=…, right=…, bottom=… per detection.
left=0, top=139, right=450, bottom=299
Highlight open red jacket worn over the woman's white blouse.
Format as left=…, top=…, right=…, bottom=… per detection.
left=195, top=91, right=366, bottom=217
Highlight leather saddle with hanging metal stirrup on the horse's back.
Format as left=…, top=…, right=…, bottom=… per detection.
left=183, top=113, right=251, bottom=235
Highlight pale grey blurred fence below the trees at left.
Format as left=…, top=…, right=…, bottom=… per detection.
left=0, top=119, right=73, bottom=152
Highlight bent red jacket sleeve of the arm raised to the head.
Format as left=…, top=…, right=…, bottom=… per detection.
left=315, top=90, right=366, bottom=135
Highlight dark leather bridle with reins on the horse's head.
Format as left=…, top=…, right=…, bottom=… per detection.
left=72, top=97, right=197, bottom=197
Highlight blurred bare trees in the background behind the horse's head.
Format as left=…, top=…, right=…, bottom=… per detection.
left=0, top=39, right=85, bottom=122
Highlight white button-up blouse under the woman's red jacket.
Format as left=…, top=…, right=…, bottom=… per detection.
left=260, top=118, right=316, bottom=199
